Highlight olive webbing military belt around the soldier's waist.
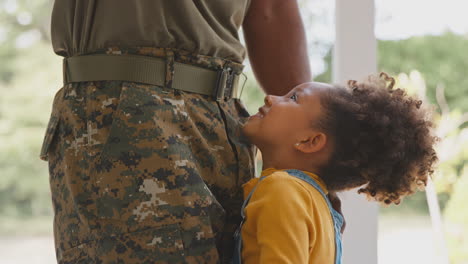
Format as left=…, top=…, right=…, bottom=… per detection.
left=63, top=54, right=240, bottom=101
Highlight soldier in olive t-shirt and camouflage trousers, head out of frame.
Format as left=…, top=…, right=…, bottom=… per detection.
left=41, top=0, right=311, bottom=263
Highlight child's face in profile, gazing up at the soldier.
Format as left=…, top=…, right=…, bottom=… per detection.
left=243, top=82, right=333, bottom=150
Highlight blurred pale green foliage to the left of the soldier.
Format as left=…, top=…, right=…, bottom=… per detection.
left=0, top=0, right=57, bottom=225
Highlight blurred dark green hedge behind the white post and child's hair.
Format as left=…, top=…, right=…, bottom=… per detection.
left=315, top=33, right=468, bottom=112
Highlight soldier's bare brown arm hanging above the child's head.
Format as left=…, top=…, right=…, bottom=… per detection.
left=243, top=0, right=312, bottom=95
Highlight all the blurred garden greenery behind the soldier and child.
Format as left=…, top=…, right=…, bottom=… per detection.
left=0, top=0, right=468, bottom=264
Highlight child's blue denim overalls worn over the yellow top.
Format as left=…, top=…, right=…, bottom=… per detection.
left=232, top=170, right=343, bottom=264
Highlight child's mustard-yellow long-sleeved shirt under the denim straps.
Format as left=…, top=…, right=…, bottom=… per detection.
left=242, top=168, right=335, bottom=264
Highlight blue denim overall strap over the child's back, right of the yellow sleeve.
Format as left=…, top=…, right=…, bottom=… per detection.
left=286, top=170, right=344, bottom=264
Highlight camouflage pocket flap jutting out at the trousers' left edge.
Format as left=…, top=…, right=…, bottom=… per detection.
left=40, top=88, right=63, bottom=161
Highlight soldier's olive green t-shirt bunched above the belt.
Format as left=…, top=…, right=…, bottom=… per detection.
left=52, top=0, right=250, bottom=62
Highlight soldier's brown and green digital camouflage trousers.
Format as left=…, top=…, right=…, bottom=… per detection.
left=41, top=48, right=254, bottom=263
